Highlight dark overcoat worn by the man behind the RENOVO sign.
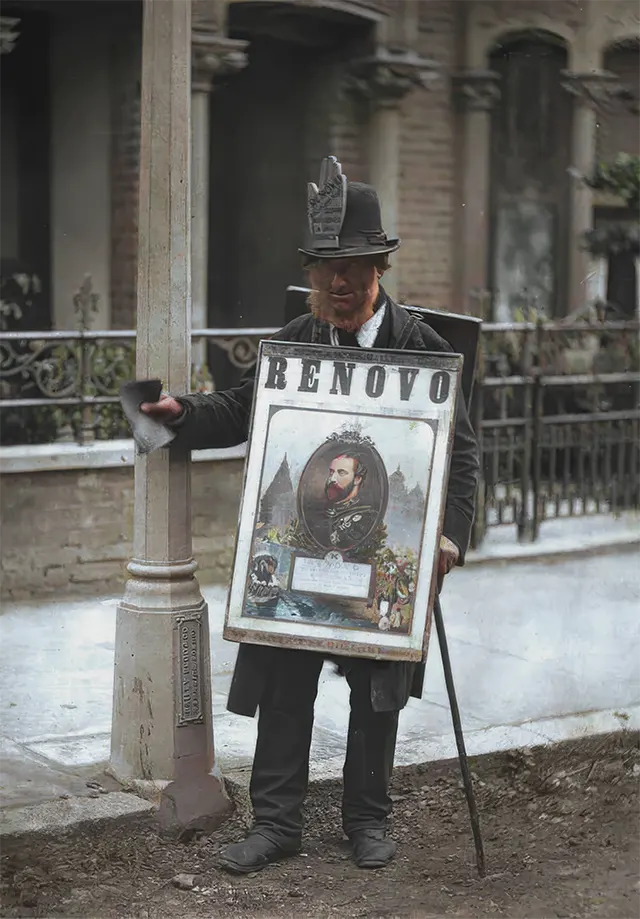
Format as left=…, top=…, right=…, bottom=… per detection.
left=172, top=297, right=479, bottom=717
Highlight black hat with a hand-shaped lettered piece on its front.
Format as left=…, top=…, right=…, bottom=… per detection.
left=298, top=156, right=400, bottom=258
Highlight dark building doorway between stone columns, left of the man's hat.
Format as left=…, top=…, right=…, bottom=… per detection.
left=209, top=2, right=373, bottom=327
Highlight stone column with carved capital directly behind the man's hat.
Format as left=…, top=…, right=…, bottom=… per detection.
left=347, top=48, right=437, bottom=298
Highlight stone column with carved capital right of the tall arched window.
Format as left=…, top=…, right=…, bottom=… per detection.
left=564, top=70, right=635, bottom=314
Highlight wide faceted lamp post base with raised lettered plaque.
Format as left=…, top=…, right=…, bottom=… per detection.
left=109, top=562, right=233, bottom=832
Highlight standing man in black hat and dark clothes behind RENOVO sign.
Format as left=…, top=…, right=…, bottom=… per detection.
left=142, top=157, right=478, bottom=873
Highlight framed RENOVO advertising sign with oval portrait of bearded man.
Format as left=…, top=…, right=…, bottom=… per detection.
left=224, top=341, right=463, bottom=661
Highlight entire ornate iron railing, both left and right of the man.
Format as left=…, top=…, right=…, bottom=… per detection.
left=0, top=322, right=640, bottom=545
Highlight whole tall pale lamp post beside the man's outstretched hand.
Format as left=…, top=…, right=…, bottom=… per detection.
left=111, top=0, right=230, bottom=828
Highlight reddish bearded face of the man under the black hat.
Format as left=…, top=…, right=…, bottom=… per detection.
left=309, top=256, right=378, bottom=332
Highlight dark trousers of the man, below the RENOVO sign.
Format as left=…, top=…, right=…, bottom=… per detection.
left=251, top=650, right=398, bottom=848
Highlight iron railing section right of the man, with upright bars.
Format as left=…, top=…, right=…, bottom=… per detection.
left=473, top=322, right=640, bottom=545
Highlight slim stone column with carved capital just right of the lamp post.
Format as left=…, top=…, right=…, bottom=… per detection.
left=191, top=28, right=247, bottom=370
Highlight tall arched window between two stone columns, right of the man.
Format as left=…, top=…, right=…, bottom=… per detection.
left=489, top=33, right=572, bottom=322
